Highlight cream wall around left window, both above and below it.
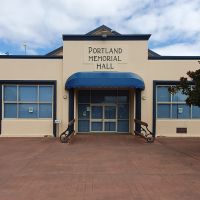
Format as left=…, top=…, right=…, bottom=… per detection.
left=0, top=59, right=63, bottom=137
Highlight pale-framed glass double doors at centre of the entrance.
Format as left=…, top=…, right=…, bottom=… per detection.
left=90, top=104, right=117, bottom=132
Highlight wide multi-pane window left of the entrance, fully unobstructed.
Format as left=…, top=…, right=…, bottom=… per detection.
left=3, top=85, right=53, bottom=118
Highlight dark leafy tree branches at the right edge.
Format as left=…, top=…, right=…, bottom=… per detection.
left=169, top=69, right=200, bottom=107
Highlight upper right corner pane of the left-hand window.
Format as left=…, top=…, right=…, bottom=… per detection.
left=39, top=86, right=53, bottom=102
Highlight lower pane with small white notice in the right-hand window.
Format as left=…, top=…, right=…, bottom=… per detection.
left=172, top=104, right=190, bottom=119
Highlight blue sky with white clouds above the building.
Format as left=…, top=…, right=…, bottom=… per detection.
left=0, top=0, right=200, bottom=56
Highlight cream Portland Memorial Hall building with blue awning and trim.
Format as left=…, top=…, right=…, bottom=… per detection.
left=0, top=26, right=200, bottom=137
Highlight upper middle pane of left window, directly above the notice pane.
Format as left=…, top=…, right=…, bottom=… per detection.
left=19, top=86, right=37, bottom=102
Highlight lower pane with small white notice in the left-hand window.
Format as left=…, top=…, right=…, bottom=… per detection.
left=19, top=104, right=38, bottom=118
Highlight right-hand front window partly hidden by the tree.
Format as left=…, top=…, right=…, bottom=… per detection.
left=156, top=85, right=200, bottom=119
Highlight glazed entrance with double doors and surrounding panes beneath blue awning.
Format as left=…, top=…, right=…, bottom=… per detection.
left=78, top=89, right=129, bottom=133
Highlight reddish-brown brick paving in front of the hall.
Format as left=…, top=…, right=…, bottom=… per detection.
left=0, top=135, right=200, bottom=200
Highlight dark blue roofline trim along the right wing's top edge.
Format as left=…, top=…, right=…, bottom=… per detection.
left=148, top=56, right=200, bottom=60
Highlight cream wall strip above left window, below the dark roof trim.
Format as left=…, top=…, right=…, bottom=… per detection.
left=0, top=59, right=62, bottom=80
